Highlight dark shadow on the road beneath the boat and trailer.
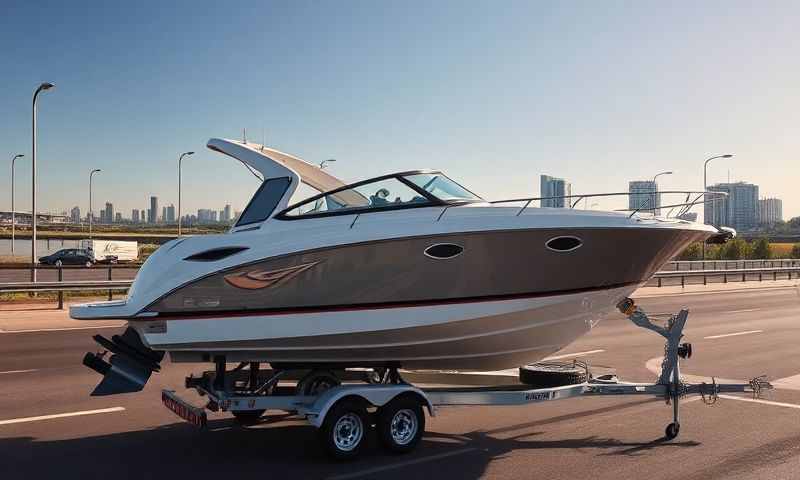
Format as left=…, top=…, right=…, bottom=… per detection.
left=0, top=406, right=700, bottom=480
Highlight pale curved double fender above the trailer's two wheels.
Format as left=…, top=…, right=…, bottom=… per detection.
left=304, top=385, right=436, bottom=428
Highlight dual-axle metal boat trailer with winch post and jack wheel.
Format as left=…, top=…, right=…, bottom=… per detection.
left=162, top=298, right=772, bottom=459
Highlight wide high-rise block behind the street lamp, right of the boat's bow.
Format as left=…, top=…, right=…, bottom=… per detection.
left=703, top=182, right=759, bottom=230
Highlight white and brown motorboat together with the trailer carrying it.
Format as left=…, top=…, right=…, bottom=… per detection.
left=70, top=139, right=765, bottom=458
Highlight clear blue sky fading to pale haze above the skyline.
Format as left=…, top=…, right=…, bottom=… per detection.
left=0, top=0, right=800, bottom=219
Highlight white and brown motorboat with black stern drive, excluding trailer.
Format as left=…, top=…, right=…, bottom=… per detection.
left=70, top=139, right=724, bottom=394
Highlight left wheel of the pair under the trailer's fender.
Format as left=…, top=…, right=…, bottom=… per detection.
left=318, top=398, right=369, bottom=460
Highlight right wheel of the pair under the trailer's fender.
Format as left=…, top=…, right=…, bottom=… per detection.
left=377, top=395, right=425, bottom=453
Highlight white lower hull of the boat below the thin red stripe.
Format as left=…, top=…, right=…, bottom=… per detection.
left=141, top=285, right=636, bottom=370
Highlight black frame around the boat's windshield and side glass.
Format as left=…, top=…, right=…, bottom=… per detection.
left=273, top=170, right=485, bottom=220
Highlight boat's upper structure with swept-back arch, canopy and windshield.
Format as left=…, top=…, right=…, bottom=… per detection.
left=207, top=138, right=484, bottom=232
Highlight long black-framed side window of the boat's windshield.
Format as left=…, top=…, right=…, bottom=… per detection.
left=285, top=177, right=430, bottom=217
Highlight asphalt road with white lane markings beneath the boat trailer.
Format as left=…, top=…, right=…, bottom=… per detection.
left=0, top=289, right=800, bottom=480
